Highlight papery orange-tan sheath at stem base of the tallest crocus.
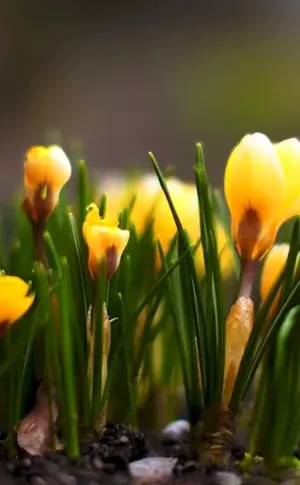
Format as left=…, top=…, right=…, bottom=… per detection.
left=223, top=297, right=254, bottom=405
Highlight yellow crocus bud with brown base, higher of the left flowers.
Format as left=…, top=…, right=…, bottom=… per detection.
left=24, top=145, right=72, bottom=222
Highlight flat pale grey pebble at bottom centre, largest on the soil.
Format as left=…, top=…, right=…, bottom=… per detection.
left=129, top=456, right=177, bottom=482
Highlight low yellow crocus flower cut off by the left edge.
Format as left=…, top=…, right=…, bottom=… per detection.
left=0, top=275, right=34, bottom=334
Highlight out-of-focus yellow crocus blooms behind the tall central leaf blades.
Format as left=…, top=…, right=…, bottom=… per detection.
left=99, top=174, right=234, bottom=277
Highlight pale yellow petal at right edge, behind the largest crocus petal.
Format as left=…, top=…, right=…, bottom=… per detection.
left=274, top=138, right=300, bottom=224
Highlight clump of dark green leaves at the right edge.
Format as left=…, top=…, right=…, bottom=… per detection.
left=251, top=218, right=300, bottom=467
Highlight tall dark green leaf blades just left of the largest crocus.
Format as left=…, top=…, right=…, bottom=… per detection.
left=150, top=145, right=229, bottom=432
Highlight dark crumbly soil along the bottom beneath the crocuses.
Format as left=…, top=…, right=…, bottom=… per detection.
left=0, top=425, right=296, bottom=485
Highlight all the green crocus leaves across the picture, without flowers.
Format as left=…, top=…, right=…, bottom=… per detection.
left=0, top=144, right=300, bottom=464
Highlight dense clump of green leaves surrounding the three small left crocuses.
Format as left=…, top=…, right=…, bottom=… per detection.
left=0, top=155, right=192, bottom=456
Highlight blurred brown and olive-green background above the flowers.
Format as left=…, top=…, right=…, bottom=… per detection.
left=0, top=0, right=300, bottom=199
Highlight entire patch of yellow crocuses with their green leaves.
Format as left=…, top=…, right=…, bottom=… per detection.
left=0, top=133, right=300, bottom=474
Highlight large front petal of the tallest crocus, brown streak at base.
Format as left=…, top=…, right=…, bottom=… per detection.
left=224, top=133, right=286, bottom=258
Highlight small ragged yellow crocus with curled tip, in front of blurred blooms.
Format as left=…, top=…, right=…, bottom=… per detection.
left=82, top=204, right=130, bottom=279
